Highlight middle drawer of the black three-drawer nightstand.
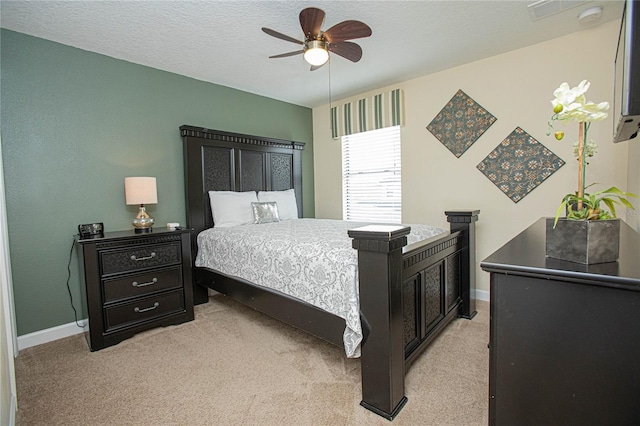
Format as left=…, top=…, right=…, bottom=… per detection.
left=102, top=266, right=182, bottom=303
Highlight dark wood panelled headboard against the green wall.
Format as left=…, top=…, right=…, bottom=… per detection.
left=180, top=125, right=304, bottom=238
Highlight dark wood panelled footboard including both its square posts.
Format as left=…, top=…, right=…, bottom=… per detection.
left=349, top=210, right=479, bottom=420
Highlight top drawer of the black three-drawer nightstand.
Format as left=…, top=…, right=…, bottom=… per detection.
left=100, top=242, right=182, bottom=275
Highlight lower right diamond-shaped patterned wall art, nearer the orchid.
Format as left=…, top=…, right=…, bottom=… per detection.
left=477, top=127, right=565, bottom=203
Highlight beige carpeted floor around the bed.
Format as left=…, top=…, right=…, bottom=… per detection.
left=16, top=296, right=489, bottom=426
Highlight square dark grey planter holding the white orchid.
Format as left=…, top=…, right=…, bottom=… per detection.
left=546, top=218, right=620, bottom=265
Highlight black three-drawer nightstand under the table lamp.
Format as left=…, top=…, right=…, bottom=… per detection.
left=77, top=228, right=193, bottom=351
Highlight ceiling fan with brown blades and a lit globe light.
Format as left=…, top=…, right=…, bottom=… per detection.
left=262, top=7, right=371, bottom=71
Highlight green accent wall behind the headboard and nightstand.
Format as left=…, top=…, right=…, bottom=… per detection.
left=0, top=29, right=314, bottom=335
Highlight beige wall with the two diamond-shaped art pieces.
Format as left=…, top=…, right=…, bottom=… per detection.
left=313, top=22, right=629, bottom=290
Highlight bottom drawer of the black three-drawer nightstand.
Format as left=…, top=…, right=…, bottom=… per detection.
left=104, top=289, right=185, bottom=332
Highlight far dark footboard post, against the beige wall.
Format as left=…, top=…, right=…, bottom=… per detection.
left=444, top=210, right=480, bottom=319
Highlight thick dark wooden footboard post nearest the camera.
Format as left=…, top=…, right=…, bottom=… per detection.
left=348, top=225, right=411, bottom=420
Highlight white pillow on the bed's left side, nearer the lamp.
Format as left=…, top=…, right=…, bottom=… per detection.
left=209, top=191, right=258, bottom=228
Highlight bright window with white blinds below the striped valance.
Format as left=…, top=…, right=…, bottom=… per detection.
left=342, top=126, right=402, bottom=223
